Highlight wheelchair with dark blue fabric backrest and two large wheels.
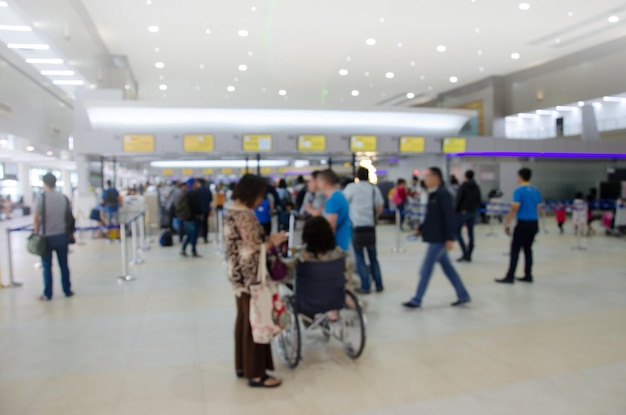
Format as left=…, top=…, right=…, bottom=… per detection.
left=274, top=258, right=366, bottom=369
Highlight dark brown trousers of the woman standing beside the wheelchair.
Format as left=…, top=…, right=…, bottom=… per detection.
left=235, top=294, right=274, bottom=379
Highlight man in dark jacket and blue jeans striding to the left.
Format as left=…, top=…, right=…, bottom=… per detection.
left=402, top=167, right=471, bottom=308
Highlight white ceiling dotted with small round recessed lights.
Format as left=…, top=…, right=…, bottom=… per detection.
left=77, top=0, right=626, bottom=108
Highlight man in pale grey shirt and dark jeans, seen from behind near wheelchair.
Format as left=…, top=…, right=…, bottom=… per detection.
left=343, top=167, right=385, bottom=294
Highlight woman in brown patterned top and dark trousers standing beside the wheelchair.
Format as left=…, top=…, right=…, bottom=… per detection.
left=224, top=174, right=286, bottom=388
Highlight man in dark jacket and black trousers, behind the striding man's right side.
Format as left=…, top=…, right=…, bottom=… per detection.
left=456, top=170, right=481, bottom=262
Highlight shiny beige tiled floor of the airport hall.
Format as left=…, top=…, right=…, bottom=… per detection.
left=0, top=221, right=626, bottom=415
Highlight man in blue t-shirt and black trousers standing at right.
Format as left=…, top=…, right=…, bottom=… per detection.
left=496, top=168, right=541, bottom=284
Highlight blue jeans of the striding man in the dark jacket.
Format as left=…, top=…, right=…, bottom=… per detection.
left=411, top=243, right=470, bottom=305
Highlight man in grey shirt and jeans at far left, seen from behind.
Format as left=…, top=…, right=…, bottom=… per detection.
left=33, top=173, right=74, bottom=301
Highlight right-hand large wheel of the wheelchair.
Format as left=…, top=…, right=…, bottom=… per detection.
left=339, top=290, right=366, bottom=359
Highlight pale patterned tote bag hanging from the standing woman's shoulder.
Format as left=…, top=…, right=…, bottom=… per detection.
left=250, top=244, right=288, bottom=344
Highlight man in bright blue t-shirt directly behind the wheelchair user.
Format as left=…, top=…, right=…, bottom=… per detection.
left=317, top=169, right=352, bottom=252
